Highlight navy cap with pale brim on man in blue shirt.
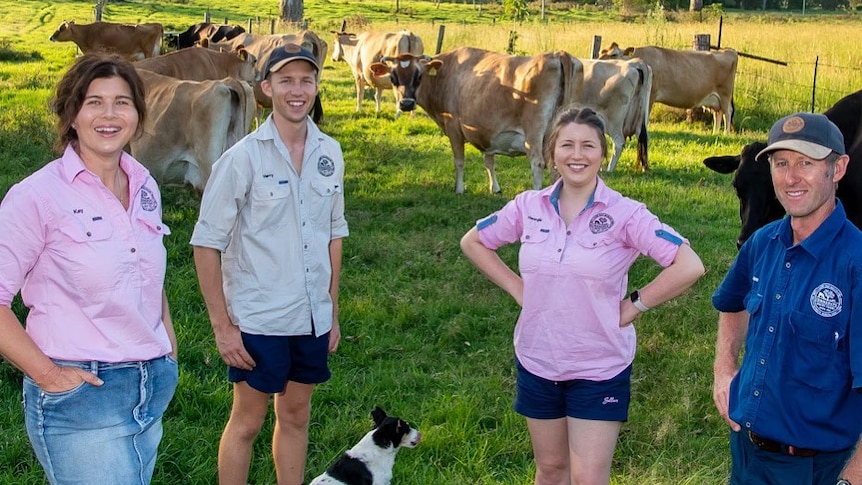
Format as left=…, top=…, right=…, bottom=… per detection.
left=755, top=113, right=845, bottom=160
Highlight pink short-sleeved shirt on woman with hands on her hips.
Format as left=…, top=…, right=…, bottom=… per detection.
left=477, top=179, right=687, bottom=381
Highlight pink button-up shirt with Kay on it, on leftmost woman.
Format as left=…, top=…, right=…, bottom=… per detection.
left=0, top=147, right=171, bottom=362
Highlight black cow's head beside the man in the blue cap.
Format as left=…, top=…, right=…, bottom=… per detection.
left=703, top=142, right=784, bottom=247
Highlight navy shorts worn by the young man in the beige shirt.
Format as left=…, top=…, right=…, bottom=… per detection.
left=227, top=332, right=332, bottom=394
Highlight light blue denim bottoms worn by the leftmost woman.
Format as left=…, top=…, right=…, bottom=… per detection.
left=23, top=356, right=179, bottom=485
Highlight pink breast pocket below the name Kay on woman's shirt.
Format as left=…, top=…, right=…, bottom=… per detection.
left=55, top=218, right=121, bottom=293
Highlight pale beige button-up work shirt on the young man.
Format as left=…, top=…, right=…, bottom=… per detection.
left=191, top=116, right=348, bottom=336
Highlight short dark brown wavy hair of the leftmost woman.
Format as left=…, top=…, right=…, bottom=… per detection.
left=51, top=52, right=147, bottom=153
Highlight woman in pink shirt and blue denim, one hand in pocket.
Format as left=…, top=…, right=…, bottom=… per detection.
left=0, top=54, right=178, bottom=485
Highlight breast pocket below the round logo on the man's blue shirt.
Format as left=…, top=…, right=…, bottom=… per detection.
left=784, top=311, right=847, bottom=389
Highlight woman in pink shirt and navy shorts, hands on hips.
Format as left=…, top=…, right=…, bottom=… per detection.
left=461, top=108, right=704, bottom=485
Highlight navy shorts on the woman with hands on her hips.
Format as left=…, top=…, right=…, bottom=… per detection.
left=513, top=359, right=632, bottom=421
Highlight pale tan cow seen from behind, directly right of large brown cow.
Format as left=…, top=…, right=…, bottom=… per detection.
left=580, top=59, right=652, bottom=172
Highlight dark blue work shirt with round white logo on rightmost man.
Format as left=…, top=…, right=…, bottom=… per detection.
left=712, top=201, right=862, bottom=451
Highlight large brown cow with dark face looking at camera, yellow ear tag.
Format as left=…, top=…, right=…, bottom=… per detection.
left=371, top=47, right=584, bottom=194
